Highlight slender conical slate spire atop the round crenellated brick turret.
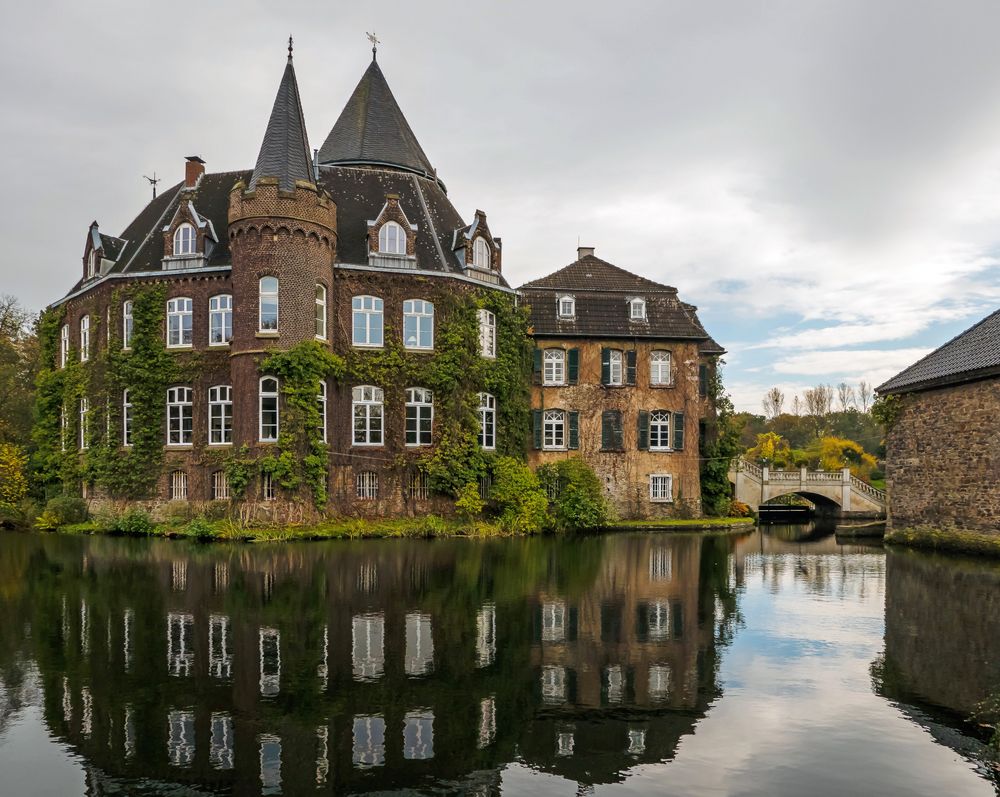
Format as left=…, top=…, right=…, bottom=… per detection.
left=250, top=46, right=313, bottom=191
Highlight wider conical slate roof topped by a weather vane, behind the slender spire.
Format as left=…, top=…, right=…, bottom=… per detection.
left=319, top=58, right=434, bottom=177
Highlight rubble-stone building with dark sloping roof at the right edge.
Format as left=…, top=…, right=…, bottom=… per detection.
left=877, top=311, right=1000, bottom=534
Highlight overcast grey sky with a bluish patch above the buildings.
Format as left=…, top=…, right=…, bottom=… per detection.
left=0, top=0, right=1000, bottom=411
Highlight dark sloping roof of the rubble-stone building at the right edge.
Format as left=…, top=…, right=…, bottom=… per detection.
left=876, top=310, right=1000, bottom=394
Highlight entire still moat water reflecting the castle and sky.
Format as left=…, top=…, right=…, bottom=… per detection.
left=0, top=527, right=1000, bottom=797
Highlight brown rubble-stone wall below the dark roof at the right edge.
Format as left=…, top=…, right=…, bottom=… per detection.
left=886, top=381, right=1000, bottom=534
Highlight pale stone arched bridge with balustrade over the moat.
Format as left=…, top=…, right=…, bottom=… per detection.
left=729, top=458, right=886, bottom=515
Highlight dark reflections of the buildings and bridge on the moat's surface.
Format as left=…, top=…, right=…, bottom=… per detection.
left=0, top=530, right=1000, bottom=795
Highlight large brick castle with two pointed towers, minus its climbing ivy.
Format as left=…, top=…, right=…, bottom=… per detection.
left=45, top=46, right=523, bottom=519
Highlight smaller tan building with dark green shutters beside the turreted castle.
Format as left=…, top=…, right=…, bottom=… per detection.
left=519, top=252, right=724, bottom=518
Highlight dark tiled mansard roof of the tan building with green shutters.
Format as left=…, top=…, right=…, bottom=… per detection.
left=518, top=255, right=725, bottom=342
